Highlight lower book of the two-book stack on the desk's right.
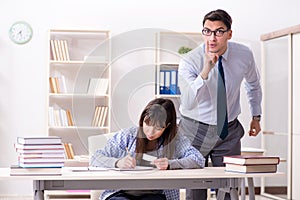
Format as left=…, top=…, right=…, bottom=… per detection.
left=225, top=163, right=277, bottom=173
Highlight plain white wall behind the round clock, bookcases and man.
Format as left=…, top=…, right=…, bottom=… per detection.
left=0, top=0, right=300, bottom=194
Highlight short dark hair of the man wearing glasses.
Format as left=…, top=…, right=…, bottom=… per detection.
left=203, top=9, right=232, bottom=30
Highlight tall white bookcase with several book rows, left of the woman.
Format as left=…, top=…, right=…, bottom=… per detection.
left=47, top=30, right=111, bottom=155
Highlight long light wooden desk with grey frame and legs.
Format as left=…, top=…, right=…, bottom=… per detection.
left=0, top=167, right=283, bottom=200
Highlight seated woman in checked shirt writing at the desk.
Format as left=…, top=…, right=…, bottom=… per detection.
left=90, top=98, right=205, bottom=200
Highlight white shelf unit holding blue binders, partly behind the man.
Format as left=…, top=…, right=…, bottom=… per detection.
left=155, top=31, right=203, bottom=122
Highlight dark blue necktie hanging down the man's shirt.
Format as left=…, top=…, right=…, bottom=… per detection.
left=217, top=56, right=228, bottom=140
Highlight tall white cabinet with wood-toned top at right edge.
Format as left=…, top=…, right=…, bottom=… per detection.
left=261, top=25, right=300, bottom=199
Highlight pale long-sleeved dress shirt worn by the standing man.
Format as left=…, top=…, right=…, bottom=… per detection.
left=178, top=42, right=262, bottom=125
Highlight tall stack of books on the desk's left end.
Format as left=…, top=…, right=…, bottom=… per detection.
left=15, top=136, right=65, bottom=168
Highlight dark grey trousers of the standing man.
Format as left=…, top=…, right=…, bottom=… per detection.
left=179, top=117, right=244, bottom=200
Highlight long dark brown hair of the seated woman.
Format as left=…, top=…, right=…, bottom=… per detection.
left=135, top=98, right=177, bottom=159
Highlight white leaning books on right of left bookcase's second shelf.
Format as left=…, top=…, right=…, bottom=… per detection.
left=87, top=78, right=109, bottom=95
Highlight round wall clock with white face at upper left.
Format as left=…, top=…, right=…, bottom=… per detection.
left=9, top=21, right=32, bottom=44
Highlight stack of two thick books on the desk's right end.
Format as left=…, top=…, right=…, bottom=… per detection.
left=223, top=155, right=280, bottom=173
